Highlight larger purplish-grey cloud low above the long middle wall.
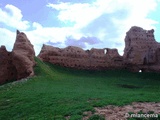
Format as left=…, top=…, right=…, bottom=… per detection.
left=65, top=36, right=101, bottom=48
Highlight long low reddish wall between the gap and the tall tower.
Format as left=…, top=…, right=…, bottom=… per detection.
left=38, top=45, right=123, bottom=70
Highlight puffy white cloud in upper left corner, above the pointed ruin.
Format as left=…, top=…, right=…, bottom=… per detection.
left=0, top=4, right=29, bottom=30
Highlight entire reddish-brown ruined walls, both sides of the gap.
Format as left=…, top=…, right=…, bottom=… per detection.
left=0, top=26, right=160, bottom=84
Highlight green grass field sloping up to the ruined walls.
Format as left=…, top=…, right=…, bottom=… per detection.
left=0, top=58, right=160, bottom=120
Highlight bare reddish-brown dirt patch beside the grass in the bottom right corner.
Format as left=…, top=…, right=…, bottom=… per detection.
left=83, top=102, right=160, bottom=120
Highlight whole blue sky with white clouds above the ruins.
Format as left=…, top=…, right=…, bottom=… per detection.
left=0, top=0, right=160, bottom=55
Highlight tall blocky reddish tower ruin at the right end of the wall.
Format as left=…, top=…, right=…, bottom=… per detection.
left=123, top=26, right=160, bottom=71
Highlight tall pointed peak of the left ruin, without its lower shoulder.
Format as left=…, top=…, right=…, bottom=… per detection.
left=12, top=31, right=35, bottom=79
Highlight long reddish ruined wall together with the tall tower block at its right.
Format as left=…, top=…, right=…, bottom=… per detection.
left=38, top=26, right=160, bottom=72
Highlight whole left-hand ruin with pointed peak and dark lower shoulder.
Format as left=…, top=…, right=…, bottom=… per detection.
left=0, top=31, right=35, bottom=84
